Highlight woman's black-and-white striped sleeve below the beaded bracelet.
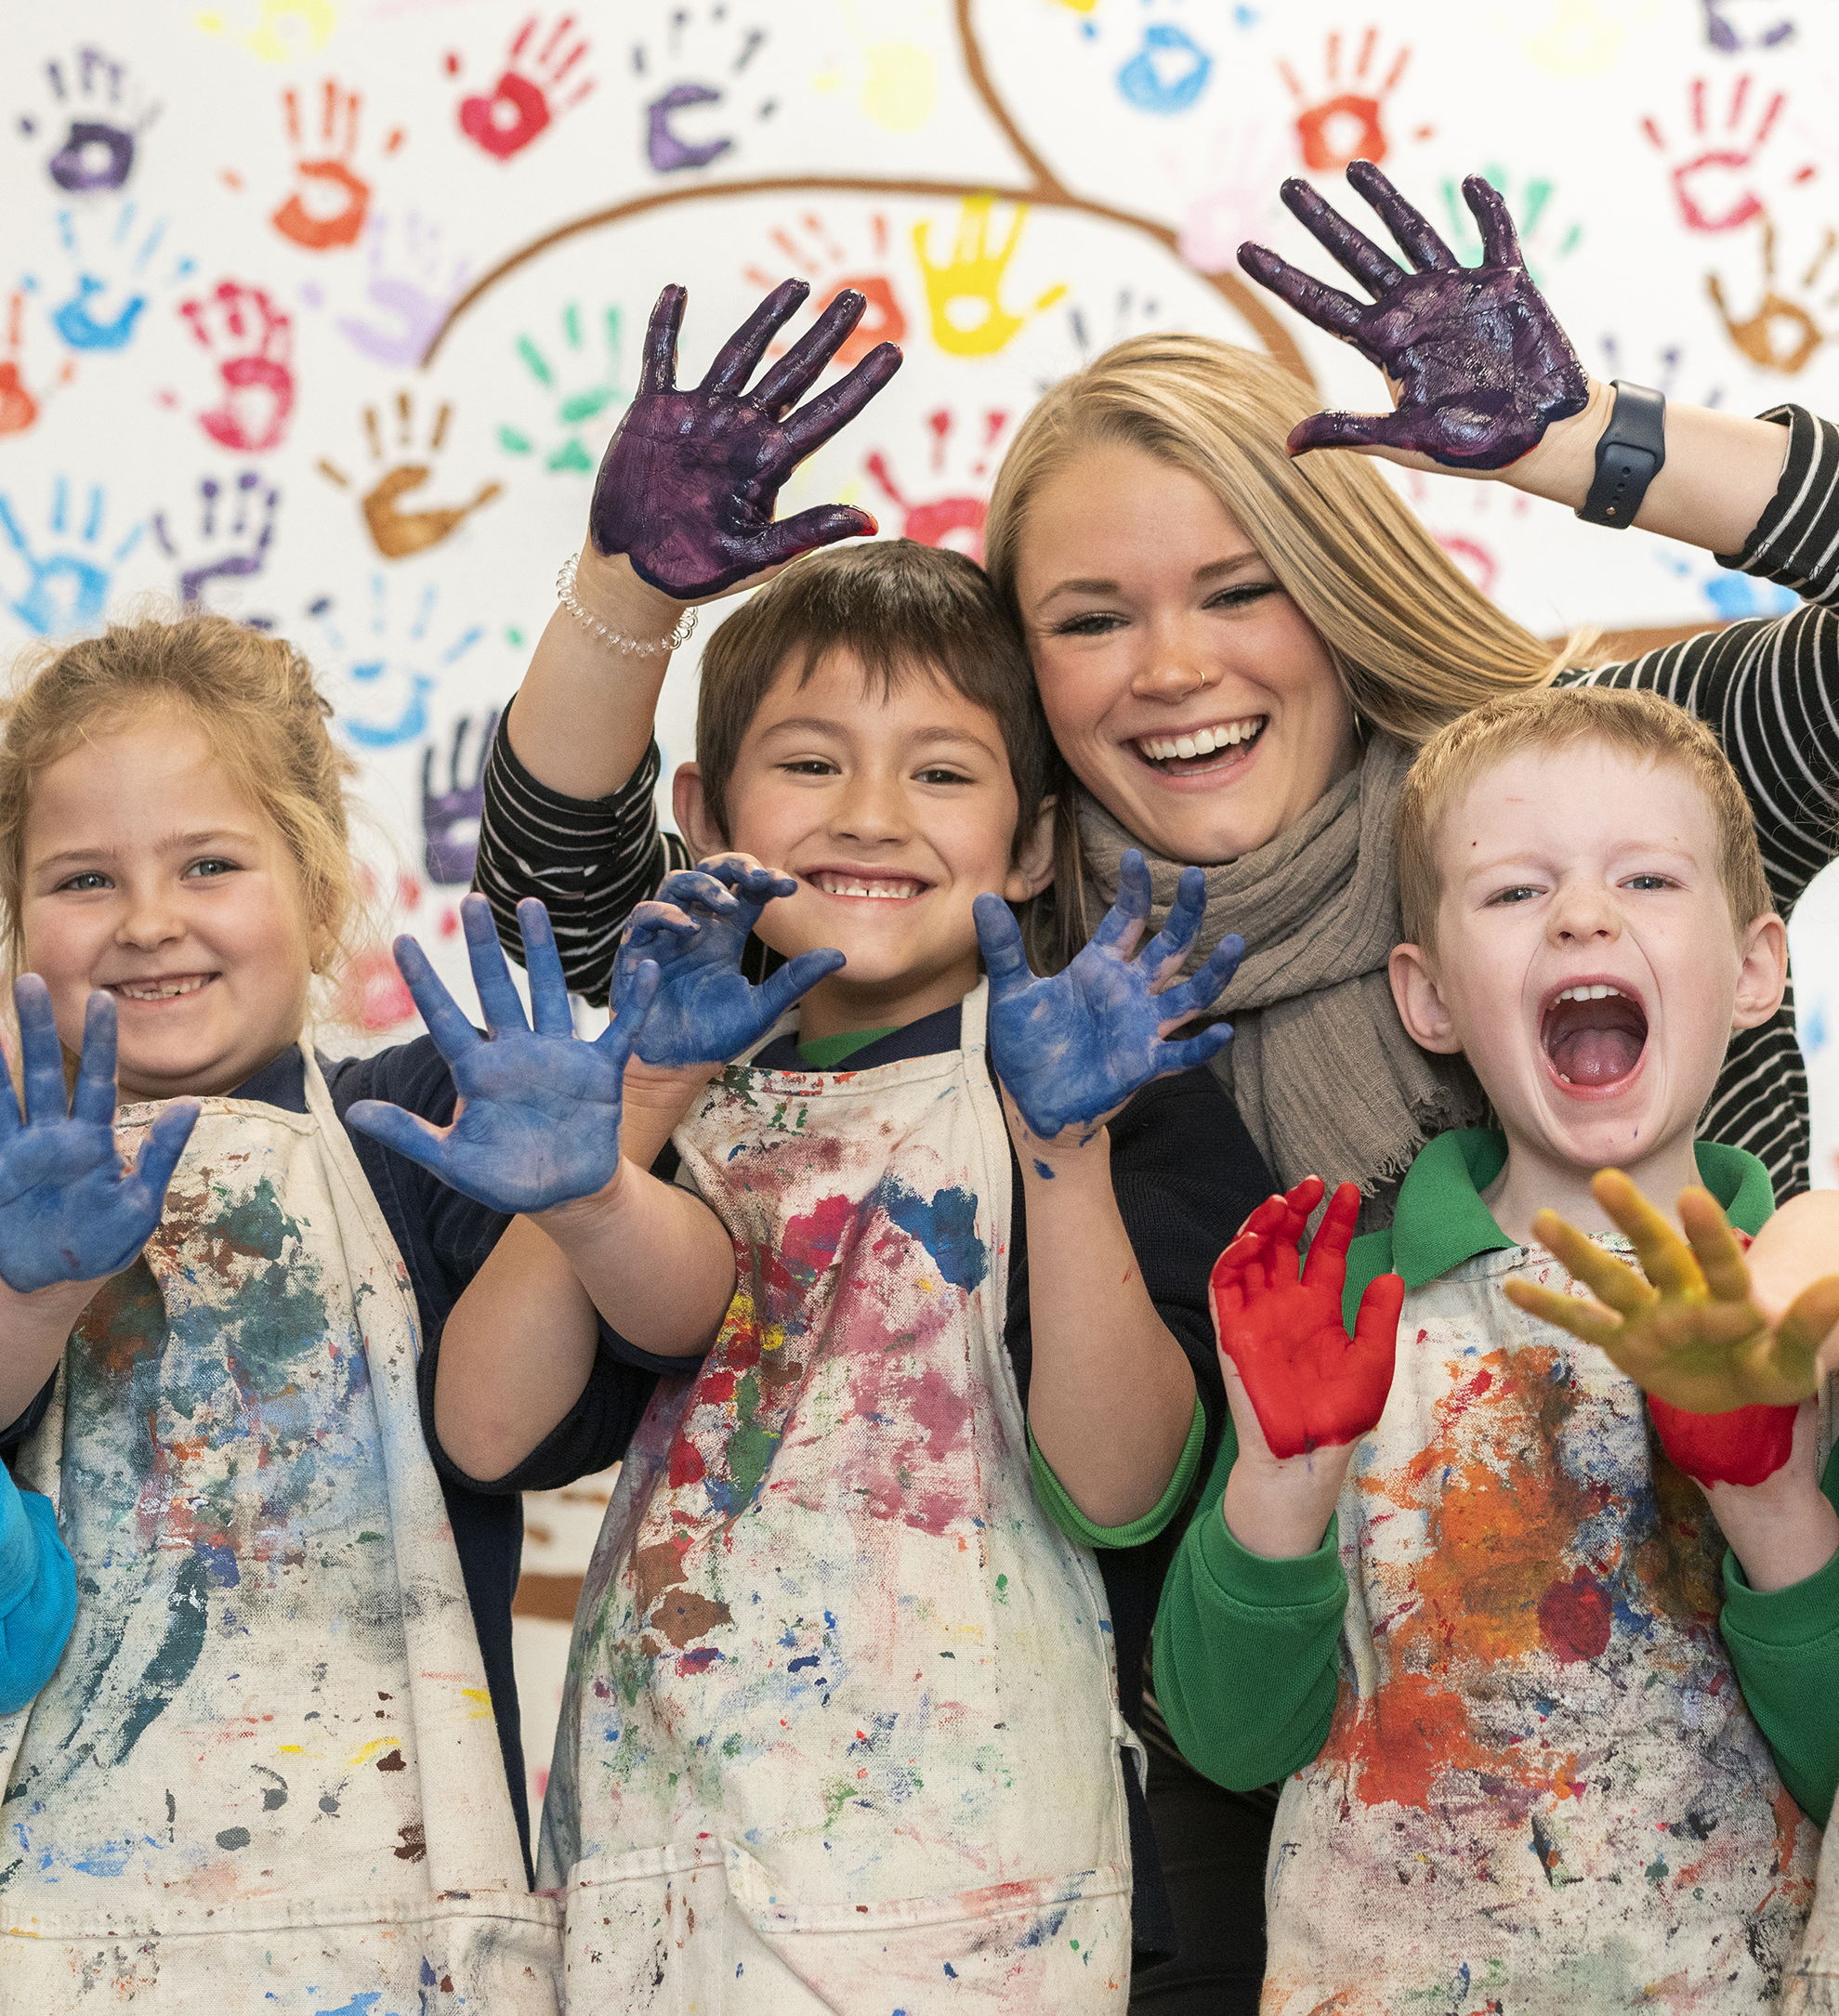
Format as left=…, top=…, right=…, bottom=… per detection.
left=472, top=708, right=690, bottom=1008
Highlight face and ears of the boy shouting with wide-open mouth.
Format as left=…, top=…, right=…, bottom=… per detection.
left=1391, top=740, right=1787, bottom=1170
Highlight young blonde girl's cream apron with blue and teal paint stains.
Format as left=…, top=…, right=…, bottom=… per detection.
left=0, top=1053, right=558, bottom=2016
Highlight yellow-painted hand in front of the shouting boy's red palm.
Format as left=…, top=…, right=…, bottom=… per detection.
left=1506, top=1170, right=1839, bottom=1413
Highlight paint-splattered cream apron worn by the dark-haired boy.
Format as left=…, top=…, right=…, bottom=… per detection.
left=538, top=986, right=1134, bottom=2016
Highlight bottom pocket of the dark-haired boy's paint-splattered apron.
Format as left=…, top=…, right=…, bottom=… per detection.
left=565, top=1839, right=1131, bottom=2016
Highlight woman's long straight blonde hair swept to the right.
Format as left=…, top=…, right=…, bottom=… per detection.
left=984, top=334, right=1591, bottom=949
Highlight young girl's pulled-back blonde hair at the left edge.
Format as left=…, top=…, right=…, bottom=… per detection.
left=0, top=615, right=361, bottom=982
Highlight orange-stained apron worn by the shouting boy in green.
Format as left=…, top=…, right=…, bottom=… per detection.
left=1262, top=1240, right=1831, bottom=2016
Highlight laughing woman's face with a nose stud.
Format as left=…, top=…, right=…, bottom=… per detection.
left=1017, top=441, right=1355, bottom=863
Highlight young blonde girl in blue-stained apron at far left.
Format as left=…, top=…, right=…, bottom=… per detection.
left=0, top=617, right=651, bottom=2016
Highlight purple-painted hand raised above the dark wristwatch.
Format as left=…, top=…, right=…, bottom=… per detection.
left=1238, top=162, right=1589, bottom=470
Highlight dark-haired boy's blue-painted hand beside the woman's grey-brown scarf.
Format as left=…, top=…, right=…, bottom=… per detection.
left=972, top=849, right=1244, bottom=1141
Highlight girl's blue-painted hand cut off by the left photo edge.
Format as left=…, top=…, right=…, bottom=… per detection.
left=0, top=974, right=198, bottom=1294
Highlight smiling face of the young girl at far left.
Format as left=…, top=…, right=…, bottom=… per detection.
left=20, top=712, right=315, bottom=1099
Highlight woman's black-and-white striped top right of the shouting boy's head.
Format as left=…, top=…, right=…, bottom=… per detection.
left=1565, top=407, right=1839, bottom=1199
